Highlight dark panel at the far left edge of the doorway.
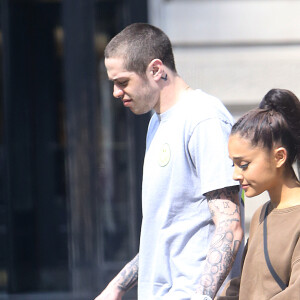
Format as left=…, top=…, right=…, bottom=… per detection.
left=0, top=1, right=68, bottom=292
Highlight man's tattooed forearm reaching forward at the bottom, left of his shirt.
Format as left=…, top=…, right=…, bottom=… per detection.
left=95, top=254, right=139, bottom=300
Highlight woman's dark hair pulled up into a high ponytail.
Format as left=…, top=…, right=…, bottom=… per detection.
left=231, top=89, right=300, bottom=164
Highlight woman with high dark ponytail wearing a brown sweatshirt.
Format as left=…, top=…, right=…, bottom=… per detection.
left=218, top=89, right=300, bottom=300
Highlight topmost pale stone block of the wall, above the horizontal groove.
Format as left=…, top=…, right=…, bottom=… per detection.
left=149, top=0, right=300, bottom=45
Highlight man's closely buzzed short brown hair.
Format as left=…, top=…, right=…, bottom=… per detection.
left=104, top=23, right=176, bottom=76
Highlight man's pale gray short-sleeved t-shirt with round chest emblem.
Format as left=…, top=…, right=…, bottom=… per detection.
left=138, top=90, right=244, bottom=300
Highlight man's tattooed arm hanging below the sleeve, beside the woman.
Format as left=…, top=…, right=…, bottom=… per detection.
left=197, top=186, right=243, bottom=298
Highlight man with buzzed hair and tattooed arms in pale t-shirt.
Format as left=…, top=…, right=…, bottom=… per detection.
left=96, top=23, right=243, bottom=300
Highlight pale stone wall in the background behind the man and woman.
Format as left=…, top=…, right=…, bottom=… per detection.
left=148, top=0, right=300, bottom=234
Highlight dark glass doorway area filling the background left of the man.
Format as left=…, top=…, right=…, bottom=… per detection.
left=0, top=0, right=149, bottom=300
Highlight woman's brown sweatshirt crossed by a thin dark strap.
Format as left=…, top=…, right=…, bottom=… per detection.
left=217, top=204, right=300, bottom=300
